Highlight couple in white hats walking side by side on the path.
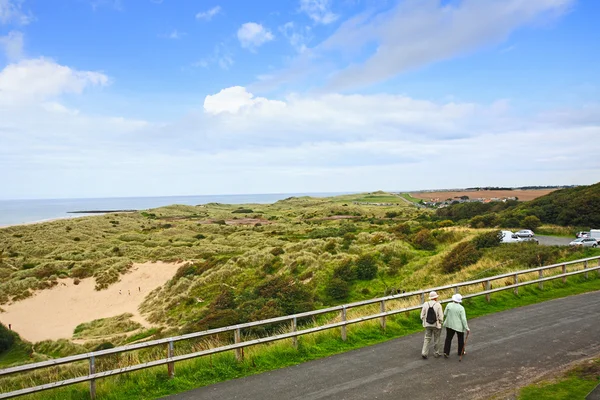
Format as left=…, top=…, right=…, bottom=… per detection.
left=421, top=292, right=470, bottom=359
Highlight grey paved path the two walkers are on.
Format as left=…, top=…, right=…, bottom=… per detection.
left=170, top=292, right=600, bottom=400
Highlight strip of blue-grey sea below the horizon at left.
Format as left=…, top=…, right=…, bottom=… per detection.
left=0, top=192, right=348, bottom=227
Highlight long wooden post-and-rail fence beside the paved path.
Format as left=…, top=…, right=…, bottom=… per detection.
left=0, top=256, right=600, bottom=399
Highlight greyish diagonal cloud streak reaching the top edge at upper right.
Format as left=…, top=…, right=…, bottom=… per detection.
left=263, top=0, right=575, bottom=91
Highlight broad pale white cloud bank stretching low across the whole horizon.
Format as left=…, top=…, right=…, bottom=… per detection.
left=0, top=83, right=600, bottom=198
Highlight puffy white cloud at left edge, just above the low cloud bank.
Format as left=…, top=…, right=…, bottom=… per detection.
left=0, top=58, right=109, bottom=103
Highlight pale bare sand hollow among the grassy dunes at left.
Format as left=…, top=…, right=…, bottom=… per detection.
left=0, top=262, right=183, bottom=342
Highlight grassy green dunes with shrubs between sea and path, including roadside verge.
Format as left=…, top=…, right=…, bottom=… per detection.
left=0, top=192, right=600, bottom=398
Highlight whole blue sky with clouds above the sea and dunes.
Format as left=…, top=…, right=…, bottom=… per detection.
left=0, top=0, right=600, bottom=199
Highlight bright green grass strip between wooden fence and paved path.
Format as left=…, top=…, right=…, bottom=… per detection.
left=7, top=273, right=600, bottom=400
